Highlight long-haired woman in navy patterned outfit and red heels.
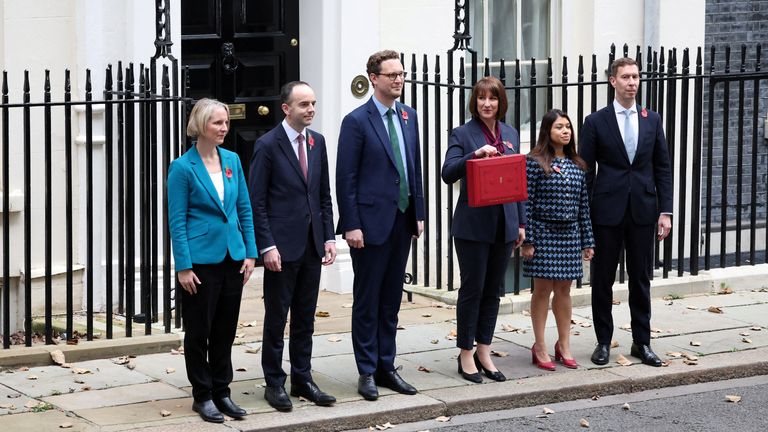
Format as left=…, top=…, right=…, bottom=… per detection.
left=522, top=109, right=595, bottom=370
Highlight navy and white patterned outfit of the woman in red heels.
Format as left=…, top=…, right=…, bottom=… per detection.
left=523, top=156, right=595, bottom=280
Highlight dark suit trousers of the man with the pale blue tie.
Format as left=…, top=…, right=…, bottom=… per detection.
left=592, top=209, right=655, bottom=345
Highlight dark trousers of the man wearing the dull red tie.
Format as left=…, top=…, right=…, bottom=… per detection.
left=261, top=231, right=322, bottom=387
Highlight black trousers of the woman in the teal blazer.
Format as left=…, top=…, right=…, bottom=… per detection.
left=181, top=254, right=243, bottom=402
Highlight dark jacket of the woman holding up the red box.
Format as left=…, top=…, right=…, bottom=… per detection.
left=441, top=119, right=526, bottom=243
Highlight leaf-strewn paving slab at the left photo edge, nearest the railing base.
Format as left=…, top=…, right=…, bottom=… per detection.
left=3, top=360, right=154, bottom=397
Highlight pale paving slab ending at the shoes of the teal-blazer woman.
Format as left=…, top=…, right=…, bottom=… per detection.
left=43, top=382, right=189, bottom=411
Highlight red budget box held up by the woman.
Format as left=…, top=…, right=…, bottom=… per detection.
left=467, top=154, right=528, bottom=207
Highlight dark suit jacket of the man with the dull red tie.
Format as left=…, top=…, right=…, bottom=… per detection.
left=248, top=124, right=334, bottom=262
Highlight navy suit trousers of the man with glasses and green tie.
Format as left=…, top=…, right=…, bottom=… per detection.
left=349, top=207, right=414, bottom=375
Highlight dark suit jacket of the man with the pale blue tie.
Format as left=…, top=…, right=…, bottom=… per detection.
left=579, top=104, right=672, bottom=226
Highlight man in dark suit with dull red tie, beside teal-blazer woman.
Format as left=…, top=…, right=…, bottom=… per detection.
left=249, top=81, right=336, bottom=411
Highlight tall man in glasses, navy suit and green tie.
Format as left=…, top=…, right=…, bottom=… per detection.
left=336, top=50, right=424, bottom=400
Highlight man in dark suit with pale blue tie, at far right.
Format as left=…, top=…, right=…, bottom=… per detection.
left=580, top=58, right=672, bottom=366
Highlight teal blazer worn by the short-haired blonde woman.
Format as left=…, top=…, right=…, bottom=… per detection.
left=167, top=146, right=257, bottom=271
